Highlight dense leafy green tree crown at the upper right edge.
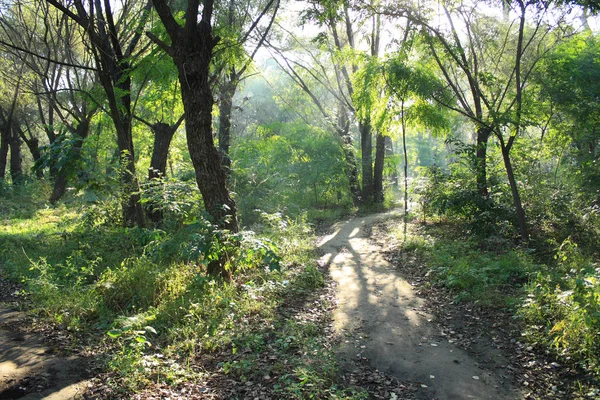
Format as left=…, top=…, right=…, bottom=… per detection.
left=534, top=31, right=600, bottom=204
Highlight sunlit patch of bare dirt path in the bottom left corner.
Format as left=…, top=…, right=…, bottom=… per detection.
left=0, top=278, right=88, bottom=400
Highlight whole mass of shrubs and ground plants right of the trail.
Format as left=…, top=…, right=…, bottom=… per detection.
left=398, top=161, right=600, bottom=393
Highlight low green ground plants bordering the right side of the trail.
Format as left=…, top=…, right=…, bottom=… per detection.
left=392, top=216, right=600, bottom=390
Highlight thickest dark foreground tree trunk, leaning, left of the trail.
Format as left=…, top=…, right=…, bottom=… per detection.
left=148, top=0, right=238, bottom=279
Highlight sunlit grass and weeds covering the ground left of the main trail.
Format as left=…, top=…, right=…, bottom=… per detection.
left=0, top=184, right=366, bottom=398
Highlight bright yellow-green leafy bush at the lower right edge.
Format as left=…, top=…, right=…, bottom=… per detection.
left=520, top=239, right=600, bottom=376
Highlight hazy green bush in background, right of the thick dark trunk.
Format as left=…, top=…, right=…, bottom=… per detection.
left=232, top=123, right=351, bottom=225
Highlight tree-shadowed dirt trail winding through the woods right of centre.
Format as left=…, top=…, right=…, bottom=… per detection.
left=320, top=214, right=520, bottom=400
